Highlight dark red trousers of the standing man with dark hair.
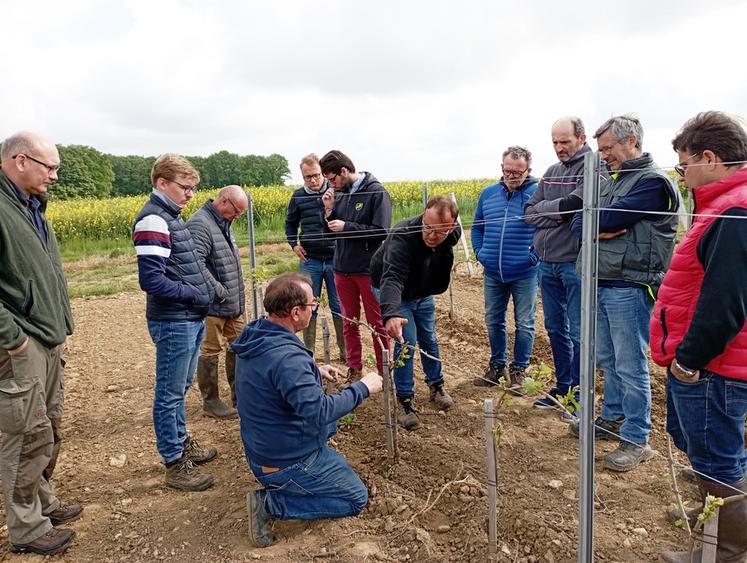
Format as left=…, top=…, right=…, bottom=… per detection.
left=335, top=272, right=387, bottom=373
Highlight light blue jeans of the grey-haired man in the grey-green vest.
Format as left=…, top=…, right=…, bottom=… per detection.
left=597, top=287, right=652, bottom=444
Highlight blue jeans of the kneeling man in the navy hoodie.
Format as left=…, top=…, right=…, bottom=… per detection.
left=251, top=446, right=368, bottom=520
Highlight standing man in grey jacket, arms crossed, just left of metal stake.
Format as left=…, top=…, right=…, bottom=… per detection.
left=524, top=116, right=591, bottom=409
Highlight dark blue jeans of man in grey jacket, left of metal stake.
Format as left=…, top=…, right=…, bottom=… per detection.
left=539, top=262, right=581, bottom=394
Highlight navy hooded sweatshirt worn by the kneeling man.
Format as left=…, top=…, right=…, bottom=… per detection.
left=232, top=318, right=368, bottom=468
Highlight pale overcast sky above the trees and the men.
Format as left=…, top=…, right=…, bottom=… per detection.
left=0, top=0, right=747, bottom=183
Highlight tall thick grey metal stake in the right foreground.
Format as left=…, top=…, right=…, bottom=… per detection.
left=578, top=152, right=600, bottom=563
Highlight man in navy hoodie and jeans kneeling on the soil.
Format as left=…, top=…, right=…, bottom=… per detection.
left=233, top=272, right=382, bottom=547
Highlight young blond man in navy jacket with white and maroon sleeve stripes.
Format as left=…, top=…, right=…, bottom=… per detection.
left=132, top=154, right=218, bottom=491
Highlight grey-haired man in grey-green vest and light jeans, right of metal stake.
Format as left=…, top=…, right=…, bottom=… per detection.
left=569, top=115, right=680, bottom=471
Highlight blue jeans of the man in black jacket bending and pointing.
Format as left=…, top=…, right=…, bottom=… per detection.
left=388, top=298, right=444, bottom=397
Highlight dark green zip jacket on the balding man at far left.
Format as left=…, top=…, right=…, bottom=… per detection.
left=0, top=170, right=73, bottom=350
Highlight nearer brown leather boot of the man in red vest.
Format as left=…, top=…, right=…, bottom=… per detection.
left=662, top=477, right=747, bottom=563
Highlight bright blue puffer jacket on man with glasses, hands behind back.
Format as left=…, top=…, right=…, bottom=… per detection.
left=471, top=176, right=539, bottom=283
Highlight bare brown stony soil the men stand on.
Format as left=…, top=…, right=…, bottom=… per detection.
left=0, top=266, right=694, bottom=562
